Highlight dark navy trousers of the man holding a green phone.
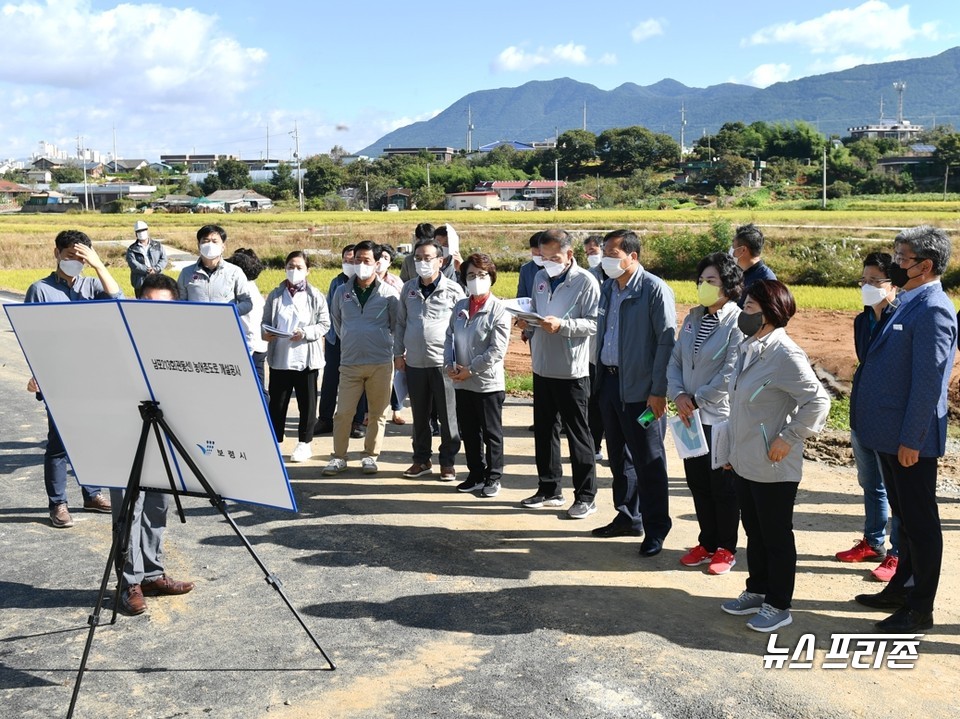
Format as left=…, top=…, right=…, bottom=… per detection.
left=598, top=365, right=673, bottom=540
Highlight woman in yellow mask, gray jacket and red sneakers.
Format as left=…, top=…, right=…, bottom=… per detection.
left=667, top=252, right=743, bottom=574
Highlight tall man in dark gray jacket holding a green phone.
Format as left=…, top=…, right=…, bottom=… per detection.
left=593, top=230, right=677, bottom=557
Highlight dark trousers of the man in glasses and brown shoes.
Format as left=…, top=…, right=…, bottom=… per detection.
left=406, top=365, right=460, bottom=467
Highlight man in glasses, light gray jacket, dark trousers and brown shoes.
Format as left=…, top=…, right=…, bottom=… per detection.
left=393, top=239, right=464, bottom=482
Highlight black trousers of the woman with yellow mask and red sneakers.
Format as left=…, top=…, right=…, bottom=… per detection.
left=683, top=424, right=740, bottom=554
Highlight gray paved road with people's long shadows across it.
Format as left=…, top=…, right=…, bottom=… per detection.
left=0, top=300, right=960, bottom=719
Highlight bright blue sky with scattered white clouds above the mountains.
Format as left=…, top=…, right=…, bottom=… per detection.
left=0, top=0, right=960, bottom=160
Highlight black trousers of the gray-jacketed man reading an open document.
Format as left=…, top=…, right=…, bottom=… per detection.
left=533, top=373, right=597, bottom=504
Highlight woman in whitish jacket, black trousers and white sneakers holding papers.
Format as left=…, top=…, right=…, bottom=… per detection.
left=262, top=250, right=330, bottom=462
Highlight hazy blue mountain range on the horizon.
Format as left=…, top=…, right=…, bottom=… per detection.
left=357, top=47, right=960, bottom=157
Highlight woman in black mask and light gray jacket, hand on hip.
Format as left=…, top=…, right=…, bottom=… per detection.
left=721, top=280, right=830, bottom=632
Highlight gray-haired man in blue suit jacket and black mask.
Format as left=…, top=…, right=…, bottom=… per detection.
left=850, top=226, right=957, bottom=633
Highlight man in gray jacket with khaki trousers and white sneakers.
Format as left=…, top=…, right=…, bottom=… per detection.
left=323, top=240, right=400, bottom=476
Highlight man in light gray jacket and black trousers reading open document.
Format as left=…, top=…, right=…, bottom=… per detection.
left=517, top=230, right=600, bottom=519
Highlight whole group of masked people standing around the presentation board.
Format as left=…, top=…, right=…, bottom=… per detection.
left=20, top=223, right=957, bottom=632
